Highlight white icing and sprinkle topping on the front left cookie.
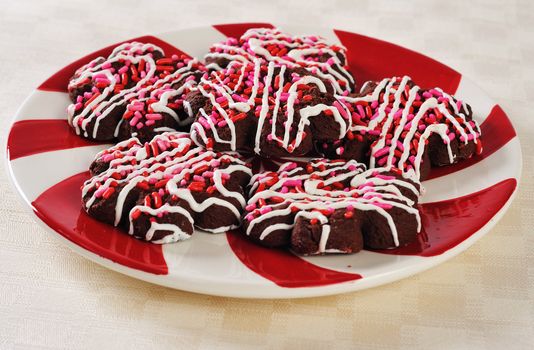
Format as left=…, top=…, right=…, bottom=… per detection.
left=82, top=132, right=252, bottom=242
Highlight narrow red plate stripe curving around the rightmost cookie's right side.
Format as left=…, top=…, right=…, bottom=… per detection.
left=427, top=105, right=516, bottom=180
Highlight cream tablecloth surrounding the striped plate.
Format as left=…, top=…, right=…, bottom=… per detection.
left=0, top=0, right=534, bottom=349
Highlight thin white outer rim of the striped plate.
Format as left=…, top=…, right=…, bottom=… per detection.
left=4, top=22, right=523, bottom=299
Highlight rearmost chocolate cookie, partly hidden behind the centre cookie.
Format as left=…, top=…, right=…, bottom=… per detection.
left=205, top=28, right=354, bottom=94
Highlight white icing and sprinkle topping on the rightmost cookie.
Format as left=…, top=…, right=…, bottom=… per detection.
left=345, top=76, right=481, bottom=179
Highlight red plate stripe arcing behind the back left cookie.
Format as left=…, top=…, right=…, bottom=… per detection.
left=38, top=35, right=189, bottom=93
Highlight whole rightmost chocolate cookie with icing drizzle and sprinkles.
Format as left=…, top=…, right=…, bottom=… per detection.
left=318, top=76, right=482, bottom=180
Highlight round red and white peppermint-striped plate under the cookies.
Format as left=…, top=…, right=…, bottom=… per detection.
left=7, top=23, right=522, bottom=298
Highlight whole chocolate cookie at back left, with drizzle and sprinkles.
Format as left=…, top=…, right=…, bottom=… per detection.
left=67, top=42, right=205, bottom=141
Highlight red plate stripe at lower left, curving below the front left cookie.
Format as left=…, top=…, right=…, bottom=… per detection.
left=32, top=172, right=168, bottom=274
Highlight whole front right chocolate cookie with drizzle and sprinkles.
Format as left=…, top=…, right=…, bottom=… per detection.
left=243, top=159, right=421, bottom=255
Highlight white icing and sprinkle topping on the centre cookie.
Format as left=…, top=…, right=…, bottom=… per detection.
left=191, top=59, right=351, bottom=154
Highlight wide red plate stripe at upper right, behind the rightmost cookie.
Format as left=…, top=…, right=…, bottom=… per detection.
left=334, top=30, right=461, bottom=94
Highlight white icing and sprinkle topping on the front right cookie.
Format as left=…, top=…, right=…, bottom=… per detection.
left=245, top=159, right=421, bottom=254
